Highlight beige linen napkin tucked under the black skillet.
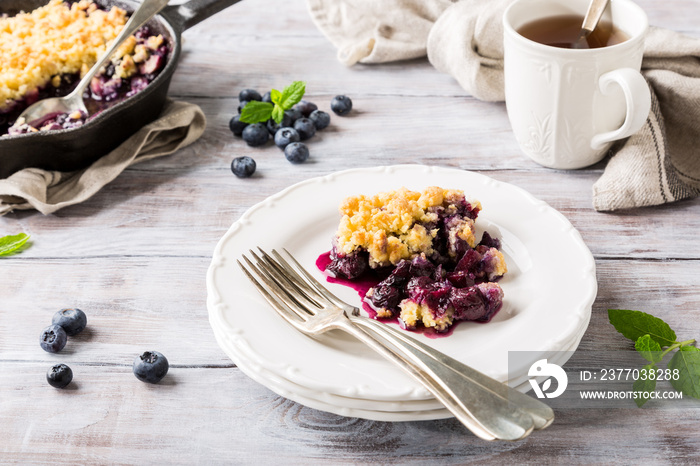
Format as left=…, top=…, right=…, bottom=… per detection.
left=0, top=100, right=206, bottom=216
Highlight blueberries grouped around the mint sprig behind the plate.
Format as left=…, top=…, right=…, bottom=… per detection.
left=229, top=89, right=352, bottom=178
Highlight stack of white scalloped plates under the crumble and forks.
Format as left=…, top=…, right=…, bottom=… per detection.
left=207, top=165, right=597, bottom=421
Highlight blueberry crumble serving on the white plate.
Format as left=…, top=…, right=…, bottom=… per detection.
left=325, top=187, right=507, bottom=333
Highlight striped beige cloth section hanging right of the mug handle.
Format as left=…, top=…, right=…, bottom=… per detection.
left=593, top=28, right=700, bottom=210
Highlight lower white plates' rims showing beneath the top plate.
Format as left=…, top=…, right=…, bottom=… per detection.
left=215, top=316, right=585, bottom=422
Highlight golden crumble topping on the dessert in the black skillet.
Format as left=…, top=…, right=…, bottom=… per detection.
left=0, top=0, right=133, bottom=110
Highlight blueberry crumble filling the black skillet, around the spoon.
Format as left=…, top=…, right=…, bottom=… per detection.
left=0, top=0, right=171, bottom=136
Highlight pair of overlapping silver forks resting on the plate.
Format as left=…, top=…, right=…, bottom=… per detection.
left=238, top=250, right=554, bottom=440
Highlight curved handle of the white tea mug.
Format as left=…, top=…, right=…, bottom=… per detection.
left=591, top=68, right=651, bottom=150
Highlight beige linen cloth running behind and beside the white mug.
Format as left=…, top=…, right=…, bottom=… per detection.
left=307, top=0, right=700, bottom=211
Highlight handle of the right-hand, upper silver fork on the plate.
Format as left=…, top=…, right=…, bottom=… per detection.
left=349, top=314, right=554, bottom=430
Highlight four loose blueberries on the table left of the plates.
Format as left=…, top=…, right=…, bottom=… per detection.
left=39, top=308, right=169, bottom=388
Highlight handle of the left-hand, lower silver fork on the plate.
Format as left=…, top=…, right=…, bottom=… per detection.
left=336, top=319, right=534, bottom=440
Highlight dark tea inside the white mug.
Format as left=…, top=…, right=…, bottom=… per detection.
left=518, top=15, right=629, bottom=49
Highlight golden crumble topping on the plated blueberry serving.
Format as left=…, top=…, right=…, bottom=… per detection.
left=336, top=187, right=481, bottom=267
